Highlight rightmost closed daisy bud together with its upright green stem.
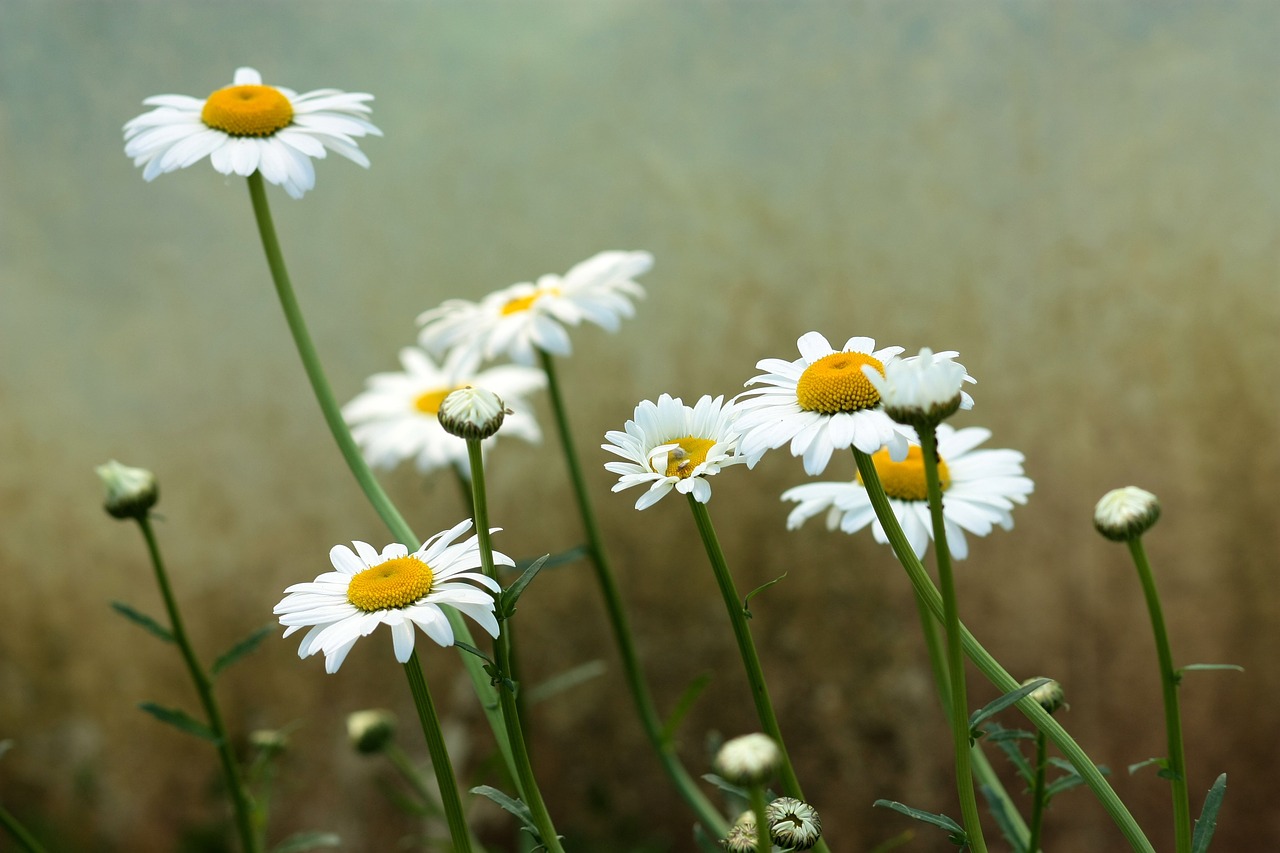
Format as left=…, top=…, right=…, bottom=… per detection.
left=1093, top=485, right=1192, bottom=853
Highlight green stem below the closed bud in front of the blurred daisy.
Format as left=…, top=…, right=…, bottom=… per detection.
left=467, top=438, right=563, bottom=853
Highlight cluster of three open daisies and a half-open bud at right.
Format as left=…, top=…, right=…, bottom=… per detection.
left=602, top=332, right=1034, bottom=558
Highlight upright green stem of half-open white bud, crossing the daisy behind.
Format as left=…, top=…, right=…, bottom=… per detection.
left=919, top=428, right=987, bottom=853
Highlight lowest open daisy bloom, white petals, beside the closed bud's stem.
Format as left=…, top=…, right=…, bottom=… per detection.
left=273, top=519, right=515, bottom=672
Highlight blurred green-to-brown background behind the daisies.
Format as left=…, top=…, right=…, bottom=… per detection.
left=0, top=0, right=1280, bottom=853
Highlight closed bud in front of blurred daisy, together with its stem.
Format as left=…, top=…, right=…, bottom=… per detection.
left=439, top=388, right=563, bottom=853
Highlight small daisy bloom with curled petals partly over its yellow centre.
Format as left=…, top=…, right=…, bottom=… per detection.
left=600, top=394, right=745, bottom=510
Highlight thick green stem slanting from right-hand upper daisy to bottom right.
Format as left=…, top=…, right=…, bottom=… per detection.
left=854, top=448, right=1155, bottom=853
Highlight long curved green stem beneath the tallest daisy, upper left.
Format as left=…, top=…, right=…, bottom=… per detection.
left=248, top=172, right=512, bottom=768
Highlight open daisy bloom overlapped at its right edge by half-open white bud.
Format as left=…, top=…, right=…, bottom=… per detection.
left=733, top=332, right=911, bottom=475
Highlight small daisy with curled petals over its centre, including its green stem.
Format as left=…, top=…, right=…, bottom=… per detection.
left=603, top=394, right=824, bottom=845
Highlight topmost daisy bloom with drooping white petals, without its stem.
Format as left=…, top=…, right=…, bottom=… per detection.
left=124, top=68, right=383, bottom=199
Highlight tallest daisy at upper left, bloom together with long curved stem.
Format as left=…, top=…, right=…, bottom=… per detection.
left=125, top=69, right=511, bottom=783
